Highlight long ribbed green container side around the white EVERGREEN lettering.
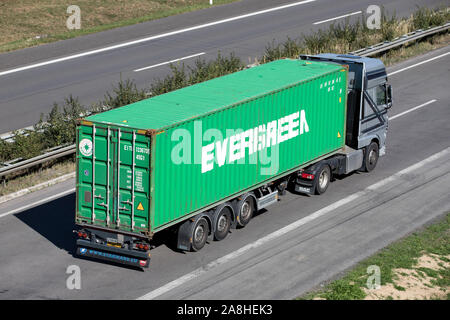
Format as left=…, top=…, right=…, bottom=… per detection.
left=152, top=69, right=347, bottom=231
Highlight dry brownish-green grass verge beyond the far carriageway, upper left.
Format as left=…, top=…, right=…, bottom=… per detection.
left=0, top=0, right=238, bottom=52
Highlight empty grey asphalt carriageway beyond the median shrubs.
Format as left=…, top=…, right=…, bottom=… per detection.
left=0, top=0, right=446, bottom=133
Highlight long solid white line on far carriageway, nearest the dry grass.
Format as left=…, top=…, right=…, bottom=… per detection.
left=0, top=0, right=316, bottom=76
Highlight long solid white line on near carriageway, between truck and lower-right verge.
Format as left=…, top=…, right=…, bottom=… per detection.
left=137, top=147, right=450, bottom=300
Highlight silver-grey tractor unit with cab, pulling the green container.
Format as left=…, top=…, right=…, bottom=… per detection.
left=295, top=53, right=392, bottom=194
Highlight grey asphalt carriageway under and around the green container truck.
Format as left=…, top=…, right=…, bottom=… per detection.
left=0, top=48, right=450, bottom=299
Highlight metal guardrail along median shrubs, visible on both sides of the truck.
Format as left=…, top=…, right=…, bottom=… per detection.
left=0, top=23, right=450, bottom=178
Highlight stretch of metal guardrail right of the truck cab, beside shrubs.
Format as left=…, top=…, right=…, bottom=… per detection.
left=350, top=22, right=450, bottom=57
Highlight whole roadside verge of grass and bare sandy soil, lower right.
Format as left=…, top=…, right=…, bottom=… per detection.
left=298, top=213, right=450, bottom=300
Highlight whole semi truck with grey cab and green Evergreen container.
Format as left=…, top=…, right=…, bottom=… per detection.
left=74, top=54, right=392, bottom=268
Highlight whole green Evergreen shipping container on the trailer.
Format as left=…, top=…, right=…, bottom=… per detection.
left=76, top=59, right=347, bottom=237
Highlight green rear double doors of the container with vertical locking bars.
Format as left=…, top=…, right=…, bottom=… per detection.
left=77, top=125, right=150, bottom=232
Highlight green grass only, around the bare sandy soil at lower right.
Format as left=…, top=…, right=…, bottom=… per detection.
left=299, top=213, right=450, bottom=300
